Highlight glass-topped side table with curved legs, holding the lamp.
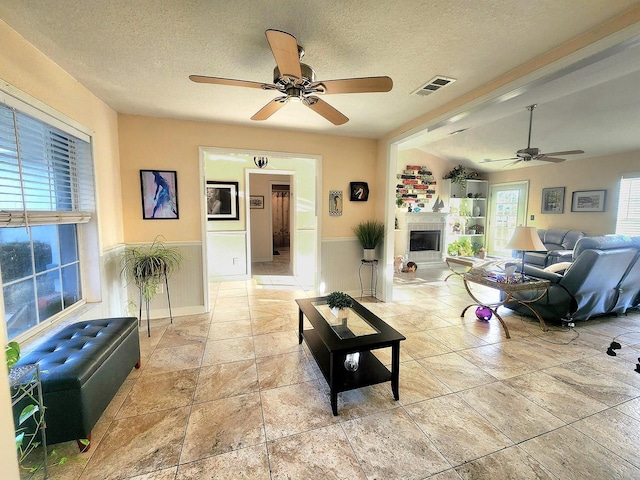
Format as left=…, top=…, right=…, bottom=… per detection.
left=460, top=270, right=551, bottom=338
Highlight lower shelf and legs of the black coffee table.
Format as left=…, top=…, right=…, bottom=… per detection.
left=303, top=329, right=399, bottom=415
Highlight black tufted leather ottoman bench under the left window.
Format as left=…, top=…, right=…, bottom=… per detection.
left=18, top=317, right=140, bottom=449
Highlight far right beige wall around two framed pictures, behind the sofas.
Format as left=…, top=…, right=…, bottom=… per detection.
left=486, top=148, right=640, bottom=235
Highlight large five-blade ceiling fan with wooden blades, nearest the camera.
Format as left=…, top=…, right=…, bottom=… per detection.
left=189, top=29, right=393, bottom=125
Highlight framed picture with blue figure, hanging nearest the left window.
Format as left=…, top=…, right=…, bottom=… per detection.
left=140, top=170, right=180, bottom=220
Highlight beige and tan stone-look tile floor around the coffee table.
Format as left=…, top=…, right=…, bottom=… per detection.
left=38, top=260, right=640, bottom=480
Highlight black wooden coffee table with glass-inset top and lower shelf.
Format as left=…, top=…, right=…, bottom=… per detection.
left=296, top=297, right=405, bottom=415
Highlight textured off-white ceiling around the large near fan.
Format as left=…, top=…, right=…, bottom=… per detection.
left=0, top=0, right=640, bottom=165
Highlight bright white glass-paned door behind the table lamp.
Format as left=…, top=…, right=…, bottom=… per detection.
left=487, top=182, right=529, bottom=256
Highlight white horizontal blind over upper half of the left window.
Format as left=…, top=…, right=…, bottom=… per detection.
left=0, top=103, right=95, bottom=226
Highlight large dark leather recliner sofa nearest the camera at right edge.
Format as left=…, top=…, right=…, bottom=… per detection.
left=503, top=235, right=640, bottom=321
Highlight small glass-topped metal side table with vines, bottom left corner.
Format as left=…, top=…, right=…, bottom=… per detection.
left=9, top=365, right=49, bottom=478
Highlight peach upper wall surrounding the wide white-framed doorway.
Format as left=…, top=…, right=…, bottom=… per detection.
left=118, top=115, right=383, bottom=243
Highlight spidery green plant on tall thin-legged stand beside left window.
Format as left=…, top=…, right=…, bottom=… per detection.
left=121, top=237, right=183, bottom=336
